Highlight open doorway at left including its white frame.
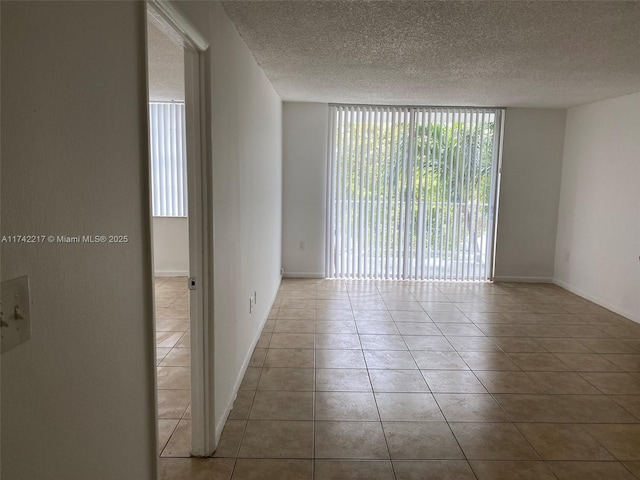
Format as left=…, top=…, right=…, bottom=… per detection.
left=147, top=1, right=215, bottom=464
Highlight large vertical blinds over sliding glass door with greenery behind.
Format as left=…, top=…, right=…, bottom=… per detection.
left=325, top=105, right=503, bottom=280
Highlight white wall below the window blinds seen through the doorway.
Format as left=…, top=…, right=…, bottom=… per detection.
left=153, top=217, right=189, bottom=277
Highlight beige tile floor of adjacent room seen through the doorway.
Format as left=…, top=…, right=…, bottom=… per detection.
left=155, top=277, right=191, bottom=457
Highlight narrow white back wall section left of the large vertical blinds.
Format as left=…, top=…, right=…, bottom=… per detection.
left=282, top=102, right=329, bottom=278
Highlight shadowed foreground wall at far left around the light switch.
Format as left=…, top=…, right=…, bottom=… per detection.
left=0, top=1, right=157, bottom=480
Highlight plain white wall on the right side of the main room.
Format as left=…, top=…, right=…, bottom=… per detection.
left=555, top=93, right=640, bottom=322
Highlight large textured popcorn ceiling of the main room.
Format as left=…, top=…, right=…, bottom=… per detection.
left=223, top=0, right=640, bottom=107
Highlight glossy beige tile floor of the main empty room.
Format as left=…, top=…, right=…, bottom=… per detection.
left=158, top=280, right=640, bottom=480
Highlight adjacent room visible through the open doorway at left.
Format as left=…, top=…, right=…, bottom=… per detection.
left=147, top=15, right=191, bottom=456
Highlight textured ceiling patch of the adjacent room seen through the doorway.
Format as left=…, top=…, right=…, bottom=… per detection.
left=147, top=21, right=184, bottom=102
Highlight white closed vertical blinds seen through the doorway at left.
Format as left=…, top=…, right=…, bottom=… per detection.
left=149, top=103, right=187, bottom=217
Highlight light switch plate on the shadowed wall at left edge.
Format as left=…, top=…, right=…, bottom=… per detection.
left=0, top=275, right=31, bottom=353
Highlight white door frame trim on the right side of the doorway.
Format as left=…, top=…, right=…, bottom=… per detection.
left=147, top=0, right=216, bottom=457
